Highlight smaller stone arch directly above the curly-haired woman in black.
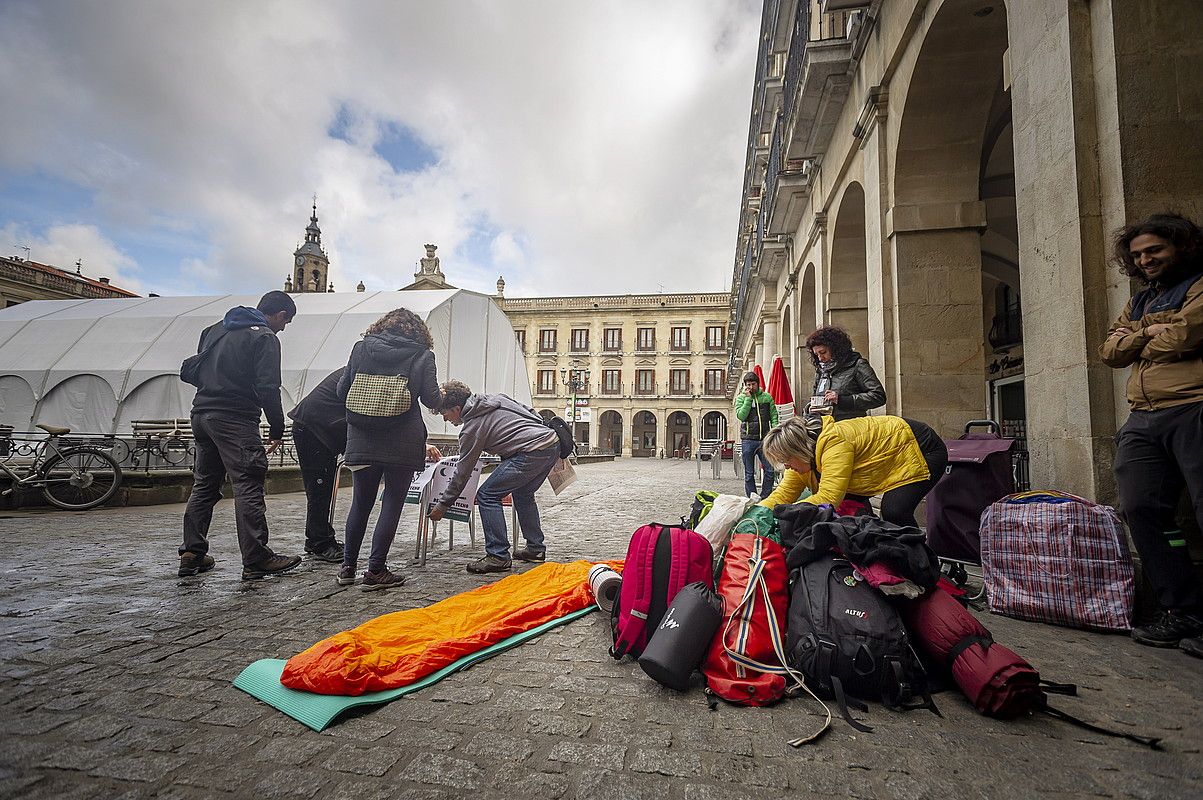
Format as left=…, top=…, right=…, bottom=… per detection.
left=826, top=180, right=869, bottom=351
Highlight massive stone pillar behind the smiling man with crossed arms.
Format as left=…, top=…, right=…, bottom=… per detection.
left=1007, top=0, right=1203, bottom=503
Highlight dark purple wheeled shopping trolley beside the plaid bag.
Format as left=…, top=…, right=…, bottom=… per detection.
left=926, top=420, right=1015, bottom=565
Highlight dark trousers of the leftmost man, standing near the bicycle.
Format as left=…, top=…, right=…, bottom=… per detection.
left=179, top=411, right=275, bottom=565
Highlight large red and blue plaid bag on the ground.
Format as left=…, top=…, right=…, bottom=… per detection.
left=980, top=492, right=1136, bottom=630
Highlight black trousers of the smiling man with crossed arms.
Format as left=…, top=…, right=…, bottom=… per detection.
left=1115, top=402, right=1203, bottom=610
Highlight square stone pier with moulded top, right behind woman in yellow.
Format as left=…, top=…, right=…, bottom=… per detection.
left=887, top=202, right=985, bottom=437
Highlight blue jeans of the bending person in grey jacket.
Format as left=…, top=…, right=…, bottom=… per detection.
left=476, top=445, right=559, bottom=559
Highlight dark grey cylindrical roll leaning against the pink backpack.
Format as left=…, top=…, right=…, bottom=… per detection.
left=639, top=582, right=723, bottom=692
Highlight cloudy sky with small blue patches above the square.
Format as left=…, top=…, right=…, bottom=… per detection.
left=0, top=0, right=760, bottom=297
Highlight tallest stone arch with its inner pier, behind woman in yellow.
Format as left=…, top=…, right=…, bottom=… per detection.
left=883, top=0, right=1018, bottom=435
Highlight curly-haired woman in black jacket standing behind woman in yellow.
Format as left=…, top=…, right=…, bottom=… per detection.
left=805, top=325, right=885, bottom=420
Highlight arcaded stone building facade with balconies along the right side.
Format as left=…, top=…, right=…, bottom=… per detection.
left=729, top=0, right=1203, bottom=502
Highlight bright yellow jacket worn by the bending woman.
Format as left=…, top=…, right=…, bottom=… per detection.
left=760, top=416, right=931, bottom=509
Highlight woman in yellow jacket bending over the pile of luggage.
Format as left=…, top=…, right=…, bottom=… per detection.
left=760, top=416, right=948, bottom=527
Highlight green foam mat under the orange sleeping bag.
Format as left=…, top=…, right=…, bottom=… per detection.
left=233, top=604, right=597, bottom=731
